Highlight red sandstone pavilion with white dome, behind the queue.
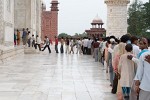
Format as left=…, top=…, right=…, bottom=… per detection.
left=85, top=16, right=106, bottom=38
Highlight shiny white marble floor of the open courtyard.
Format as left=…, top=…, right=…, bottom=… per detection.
left=0, top=47, right=116, bottom=100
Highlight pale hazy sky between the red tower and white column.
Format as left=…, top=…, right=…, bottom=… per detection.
left=45, top=0, right=148, bottom=35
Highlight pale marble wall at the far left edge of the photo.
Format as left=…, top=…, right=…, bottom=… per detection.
left=0, top=0, right=14, bottom=50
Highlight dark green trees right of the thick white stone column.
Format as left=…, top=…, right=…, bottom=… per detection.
left=128, top=0, right=150, bottom=38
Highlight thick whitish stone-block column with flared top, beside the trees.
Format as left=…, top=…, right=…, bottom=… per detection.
left=105, top=0, right=129, bottom=38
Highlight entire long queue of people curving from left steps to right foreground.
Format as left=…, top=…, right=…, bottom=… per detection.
left=14, top=29, right=150, bottom=100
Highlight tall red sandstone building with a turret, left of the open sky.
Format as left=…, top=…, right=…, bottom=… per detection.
left=41, top=0, right=59, bottom=41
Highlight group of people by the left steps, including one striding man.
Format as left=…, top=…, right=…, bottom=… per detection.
left=14, top=28, right=51, bottom=53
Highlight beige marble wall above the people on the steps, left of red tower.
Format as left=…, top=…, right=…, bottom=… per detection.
left=15, top=0, right=41, bottom=34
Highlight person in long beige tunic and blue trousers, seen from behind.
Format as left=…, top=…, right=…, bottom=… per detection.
left=118, top=44, right=135, bottom=100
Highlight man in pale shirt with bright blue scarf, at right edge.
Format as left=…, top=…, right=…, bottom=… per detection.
left=134, top=38, right=150, bottom=100
